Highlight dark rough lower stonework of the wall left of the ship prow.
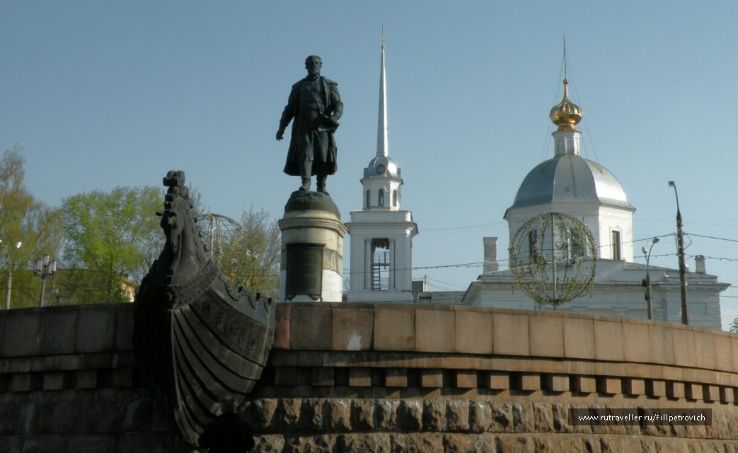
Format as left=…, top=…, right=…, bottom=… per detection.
left=0, top=388, right=186, bottom=453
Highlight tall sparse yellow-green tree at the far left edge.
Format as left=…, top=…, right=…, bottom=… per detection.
left=0, top=146, right=62, bottom=308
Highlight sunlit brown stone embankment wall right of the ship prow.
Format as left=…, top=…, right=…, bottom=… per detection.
left=249, top=304, right=738, bottom=453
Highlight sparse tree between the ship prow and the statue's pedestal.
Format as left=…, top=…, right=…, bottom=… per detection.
left=215, top=209, right=281, bottom=299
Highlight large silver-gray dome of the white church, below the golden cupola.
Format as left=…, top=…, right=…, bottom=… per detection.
left=510, top=154, right=633, bottom=209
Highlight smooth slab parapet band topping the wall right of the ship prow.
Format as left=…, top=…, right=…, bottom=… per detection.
left=275, top=303, right=738, bottom=373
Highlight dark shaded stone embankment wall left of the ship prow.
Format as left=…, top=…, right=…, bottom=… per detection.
left=0, top=304, right=185, bottom=453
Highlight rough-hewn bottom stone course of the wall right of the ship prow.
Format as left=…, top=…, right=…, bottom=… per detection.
left=243, top=398, right=738, bottom=453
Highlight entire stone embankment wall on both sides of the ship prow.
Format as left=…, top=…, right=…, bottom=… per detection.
left=0, top=304, right=738, bottom=453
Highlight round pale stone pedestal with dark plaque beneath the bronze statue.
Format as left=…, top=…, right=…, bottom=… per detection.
left=279, top=191, right=346, bottom=302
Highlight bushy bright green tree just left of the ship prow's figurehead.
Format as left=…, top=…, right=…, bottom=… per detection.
left=62, top=186, right=164, bottom=303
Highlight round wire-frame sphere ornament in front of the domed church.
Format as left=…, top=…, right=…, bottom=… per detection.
left=510, top=212, right=597, bottom=308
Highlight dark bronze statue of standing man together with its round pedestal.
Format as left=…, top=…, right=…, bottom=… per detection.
left=277, top=55, right=346, bottom=302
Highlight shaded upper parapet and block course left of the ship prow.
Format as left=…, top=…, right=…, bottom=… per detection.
left=0, top=304, right=133, bottom=392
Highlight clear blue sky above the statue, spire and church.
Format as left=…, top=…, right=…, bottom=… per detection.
left=0, top=0, right=738, bottom=324
